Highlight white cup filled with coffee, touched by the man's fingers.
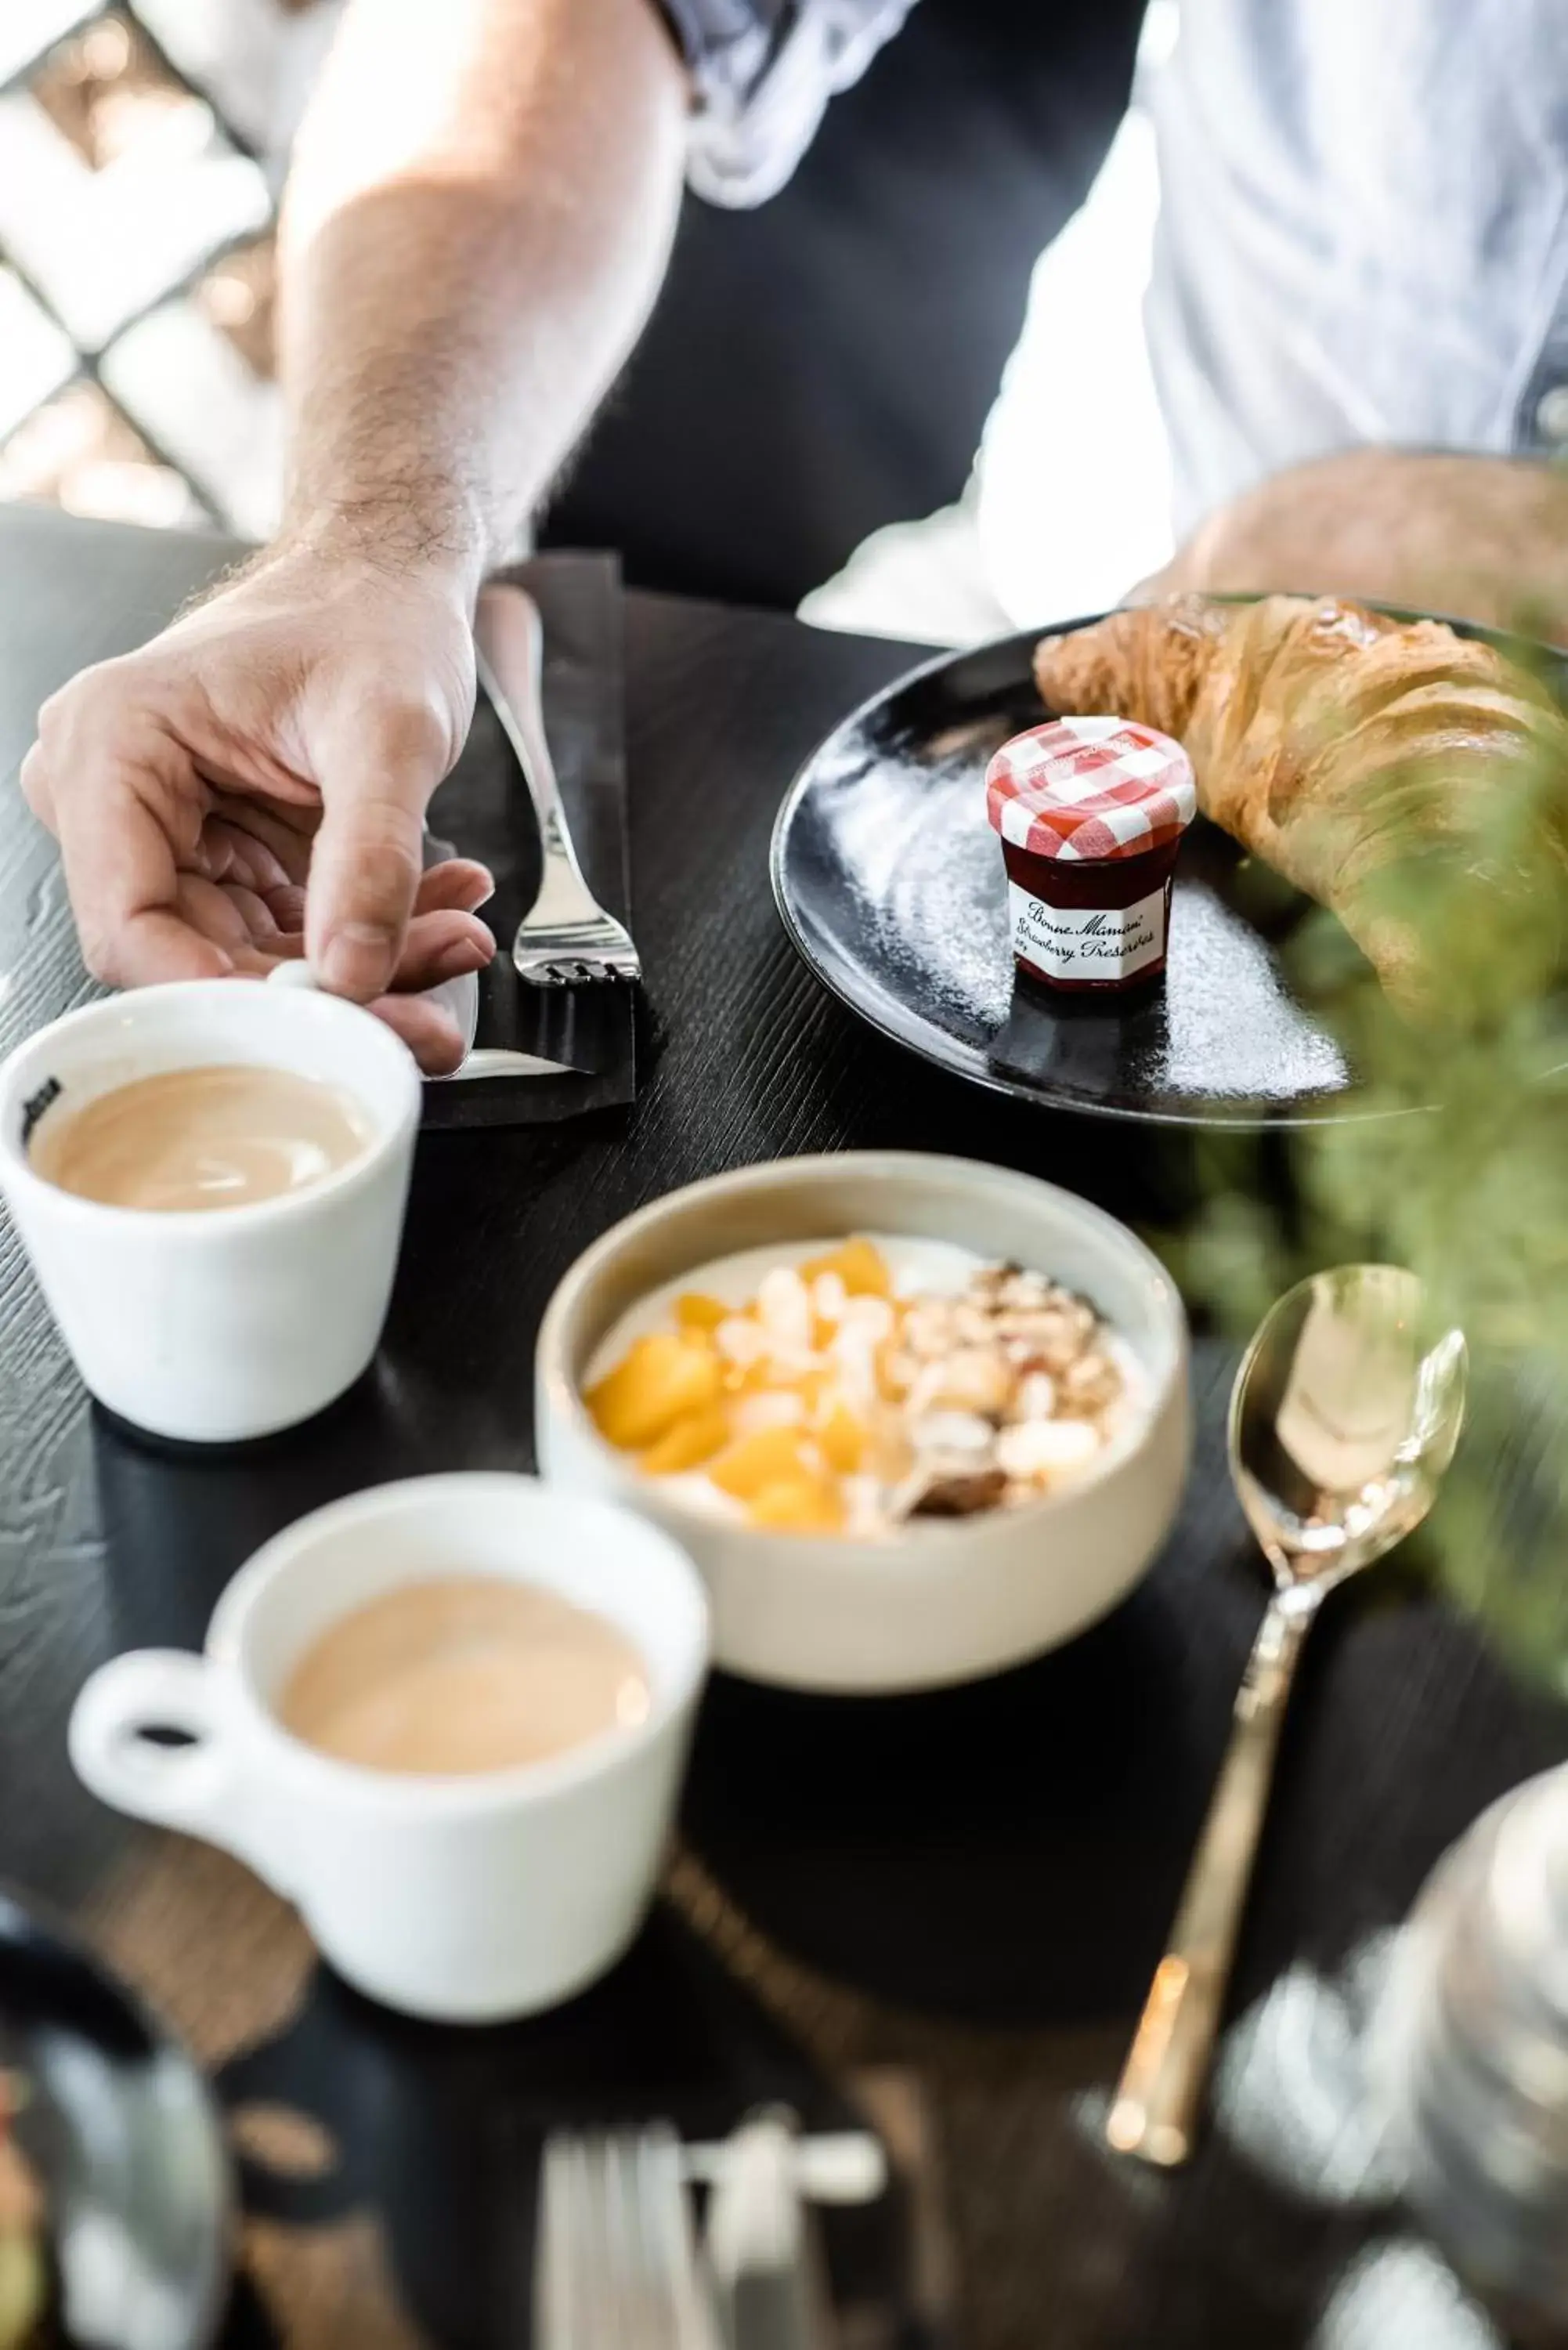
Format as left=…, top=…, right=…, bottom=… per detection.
left=0, top=980, right=421, bottom=1443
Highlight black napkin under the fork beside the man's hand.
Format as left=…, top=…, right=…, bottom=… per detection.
left=425, top=555, right=637, bottom=1126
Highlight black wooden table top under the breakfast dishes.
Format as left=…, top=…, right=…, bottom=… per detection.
left=0, top=510, right=1568, bottom=2350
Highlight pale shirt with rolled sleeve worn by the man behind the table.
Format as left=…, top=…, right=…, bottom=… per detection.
left=665, top=0, right=1568, bottom=623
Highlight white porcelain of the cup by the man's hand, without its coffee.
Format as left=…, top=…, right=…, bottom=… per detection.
left=0, top=980, right=421, bottom=1443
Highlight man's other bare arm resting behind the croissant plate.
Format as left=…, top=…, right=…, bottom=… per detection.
left=1140, top=449, right=1568, bottom=644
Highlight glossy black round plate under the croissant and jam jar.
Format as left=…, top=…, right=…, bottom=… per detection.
left=773, top=613, right=1560, bottom=1126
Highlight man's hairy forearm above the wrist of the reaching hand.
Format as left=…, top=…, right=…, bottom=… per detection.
left=282, top=0, right=686, bottom=588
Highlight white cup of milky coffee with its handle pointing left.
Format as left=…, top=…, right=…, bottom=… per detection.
left=70, top=1473, right=707, bottom=2023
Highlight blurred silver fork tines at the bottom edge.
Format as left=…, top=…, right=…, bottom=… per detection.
left=533, top=2122, right=719, bottom=2350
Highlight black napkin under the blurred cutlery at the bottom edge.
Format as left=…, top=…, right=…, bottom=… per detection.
left=216, top=1906, right=943, bottom=2350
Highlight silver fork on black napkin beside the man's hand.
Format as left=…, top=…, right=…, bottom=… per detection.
left=475, top=580, right=641, bottom=987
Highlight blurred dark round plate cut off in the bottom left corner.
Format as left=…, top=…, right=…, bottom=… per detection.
left=0, top=1894, right=230, bottom=2350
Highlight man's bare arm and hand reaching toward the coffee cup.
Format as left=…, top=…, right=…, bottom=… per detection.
left=23, top=0, right=686, bottom=1069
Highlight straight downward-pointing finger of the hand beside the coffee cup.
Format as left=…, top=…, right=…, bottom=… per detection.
left=305, top=705, right=451, bottom=1003
